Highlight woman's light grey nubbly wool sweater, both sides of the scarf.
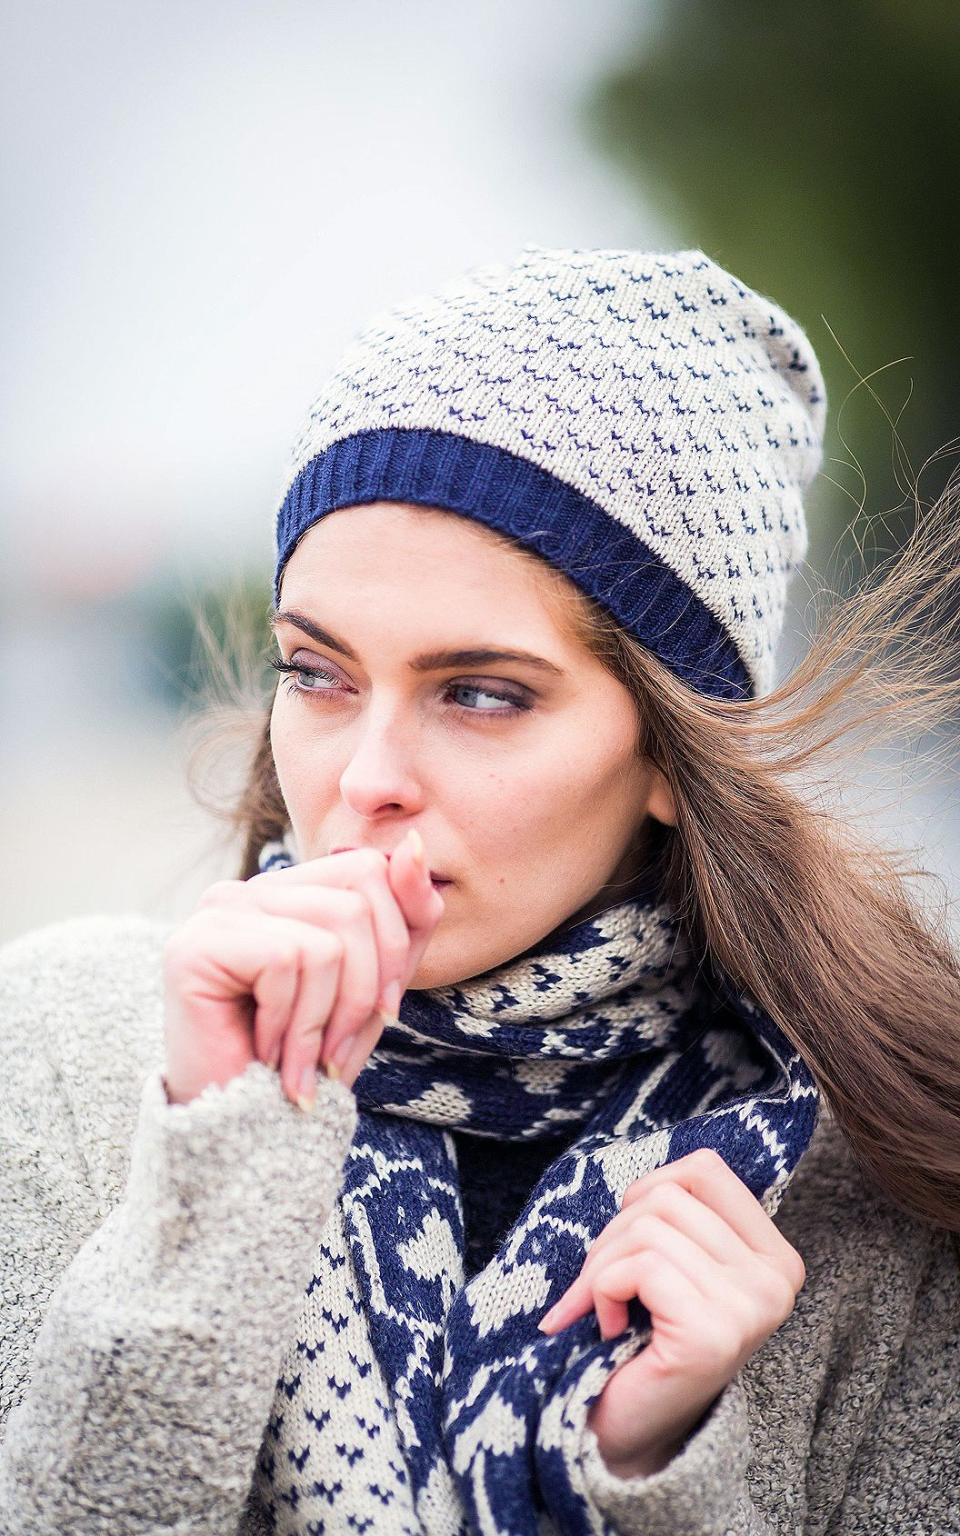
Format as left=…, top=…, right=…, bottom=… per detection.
left=0, top=917, right=960, bottom=1536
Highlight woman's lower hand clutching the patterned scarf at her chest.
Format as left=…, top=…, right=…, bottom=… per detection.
left=539, top=1147, right=806, bottom=1478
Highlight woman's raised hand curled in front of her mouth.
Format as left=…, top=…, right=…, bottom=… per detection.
left=163, top=829, right=444, bottom=1107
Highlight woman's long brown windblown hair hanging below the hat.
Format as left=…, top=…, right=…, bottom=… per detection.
left=181, top=470, right=960, bottom=1232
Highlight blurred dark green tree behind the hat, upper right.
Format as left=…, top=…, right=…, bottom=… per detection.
left=581, top=0, right=960, bottom=577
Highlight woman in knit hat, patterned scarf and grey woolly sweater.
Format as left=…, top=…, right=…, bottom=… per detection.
left=0, top=246, right=960, bottom=1536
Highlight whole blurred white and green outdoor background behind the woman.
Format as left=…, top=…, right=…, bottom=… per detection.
left=0, top=0, right=960, bottom=940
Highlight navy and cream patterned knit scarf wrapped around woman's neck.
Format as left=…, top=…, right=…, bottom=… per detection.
left=253, top=833, right=819, bottom=1536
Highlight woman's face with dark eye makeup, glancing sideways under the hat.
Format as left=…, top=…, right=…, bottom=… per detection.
left=270, top=502, right=674, bottom=988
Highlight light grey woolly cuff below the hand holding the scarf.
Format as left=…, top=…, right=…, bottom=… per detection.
left=571, top=1376, right=750, bottom=1536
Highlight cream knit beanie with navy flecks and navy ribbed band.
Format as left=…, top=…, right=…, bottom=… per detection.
left=273, top=244, right=826, bottom=699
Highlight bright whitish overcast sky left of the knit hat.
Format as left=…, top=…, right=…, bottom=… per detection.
left=0, top=0, right=671, bottom=596
